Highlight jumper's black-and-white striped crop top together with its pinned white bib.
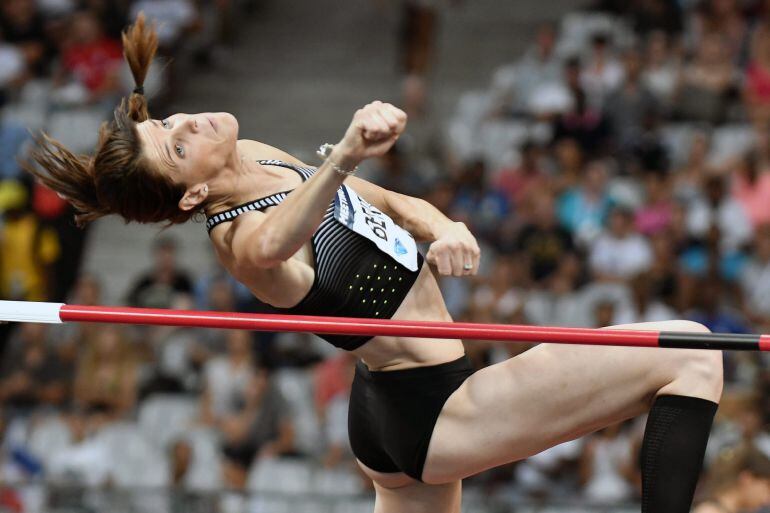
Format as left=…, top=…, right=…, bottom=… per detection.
left=206, top=160, right=424, bottom=351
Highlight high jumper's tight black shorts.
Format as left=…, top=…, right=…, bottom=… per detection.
left=348, top=356, right=473, bottom=481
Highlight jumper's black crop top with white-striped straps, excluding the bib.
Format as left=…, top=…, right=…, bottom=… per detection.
left=206, top=160, right=423, bottom=350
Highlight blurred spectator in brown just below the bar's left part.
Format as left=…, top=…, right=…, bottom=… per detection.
left=74, top=325, right=138, bottom=421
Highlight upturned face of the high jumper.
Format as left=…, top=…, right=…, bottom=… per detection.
left=137, top=112, right=238, bottom=208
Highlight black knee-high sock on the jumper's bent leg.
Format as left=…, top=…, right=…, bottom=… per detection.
left=641, top=395, right=717, bottom=513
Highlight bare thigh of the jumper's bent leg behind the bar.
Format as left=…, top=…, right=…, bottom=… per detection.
left=423, top=321, right=708, bottom=483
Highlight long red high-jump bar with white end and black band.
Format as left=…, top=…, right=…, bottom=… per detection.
left=0, top=301, right=770, bottom=351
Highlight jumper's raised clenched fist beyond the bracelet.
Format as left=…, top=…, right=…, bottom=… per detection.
left=337, top=101, right=406, bottom=162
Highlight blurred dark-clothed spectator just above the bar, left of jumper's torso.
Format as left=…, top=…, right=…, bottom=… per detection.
left=128, top=238, right=193, bottom=308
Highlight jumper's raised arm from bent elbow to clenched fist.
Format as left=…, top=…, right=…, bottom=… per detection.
left=232, top=102, right=406, bottom=268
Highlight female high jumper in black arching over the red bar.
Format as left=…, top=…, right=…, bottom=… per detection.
left=28, top=18, right=722, bottom=513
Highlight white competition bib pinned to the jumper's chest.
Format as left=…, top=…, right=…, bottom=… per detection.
left=334, top=185, right=417, bottom=271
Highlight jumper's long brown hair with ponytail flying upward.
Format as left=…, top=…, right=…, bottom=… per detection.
left=22, top=13, right=193, bottom=225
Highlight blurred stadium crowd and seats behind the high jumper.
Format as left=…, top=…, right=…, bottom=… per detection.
left=0, top=0, right=770, bottom=513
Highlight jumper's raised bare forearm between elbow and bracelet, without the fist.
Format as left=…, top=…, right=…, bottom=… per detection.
left=256, top=149, right=358, bottom=261
